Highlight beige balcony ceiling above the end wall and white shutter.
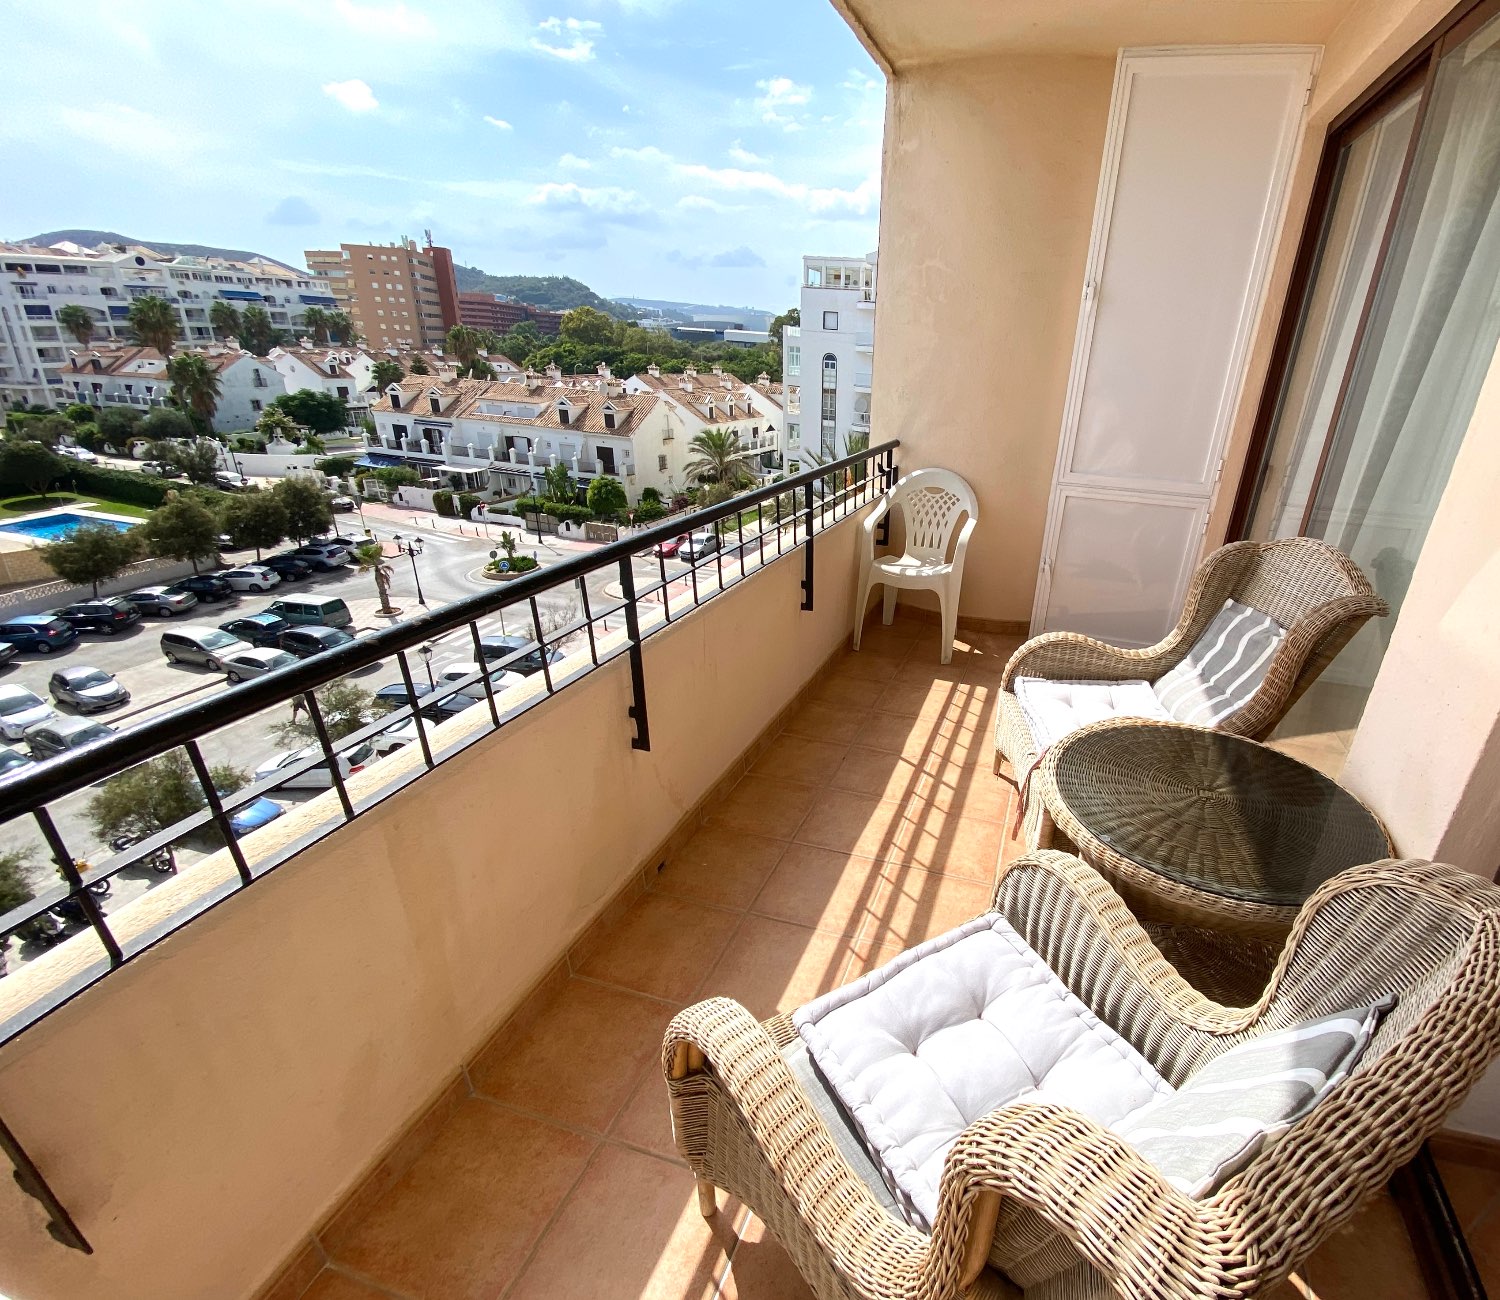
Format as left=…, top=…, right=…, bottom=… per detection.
left=833, top=0, right=1353, bottom=69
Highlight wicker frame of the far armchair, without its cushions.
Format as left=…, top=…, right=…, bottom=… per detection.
left=995, top=537, right=1389, bottom=849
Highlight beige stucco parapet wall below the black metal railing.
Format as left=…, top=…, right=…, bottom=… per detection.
left=0, top=512, right=858, bottom=1300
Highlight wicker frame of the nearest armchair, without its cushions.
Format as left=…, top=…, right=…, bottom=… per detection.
left=663, top=852, right=1500, bottom=1300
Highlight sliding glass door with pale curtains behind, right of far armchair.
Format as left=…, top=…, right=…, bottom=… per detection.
left=1242, top=2, right=1500, bottom=768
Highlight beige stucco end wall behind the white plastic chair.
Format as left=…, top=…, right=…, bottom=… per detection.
left=872, top=57, right=1115, bottom=621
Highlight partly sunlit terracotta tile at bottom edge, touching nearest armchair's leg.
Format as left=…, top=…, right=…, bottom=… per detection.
left=509, top=1144, right=735, bottom=1300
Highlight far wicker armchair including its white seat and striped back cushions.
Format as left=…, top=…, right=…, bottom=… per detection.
left=995, top=537, right=1388, bottom=849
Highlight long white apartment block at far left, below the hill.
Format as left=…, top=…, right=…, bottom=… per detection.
left=0, top=243, right=335, bottom=406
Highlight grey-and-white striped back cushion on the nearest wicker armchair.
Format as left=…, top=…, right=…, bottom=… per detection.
left=1116, top=997, right=1395, bottom=1198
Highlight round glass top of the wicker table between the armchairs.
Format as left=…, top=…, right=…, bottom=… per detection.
left=1053, top=723, right=1391, bottom=907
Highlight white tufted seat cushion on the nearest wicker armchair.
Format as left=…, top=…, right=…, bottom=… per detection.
left=794, top=913, right=1173, bottom=1230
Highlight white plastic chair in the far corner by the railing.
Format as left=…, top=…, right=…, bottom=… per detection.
left=854, top=469, right=980, bottom=663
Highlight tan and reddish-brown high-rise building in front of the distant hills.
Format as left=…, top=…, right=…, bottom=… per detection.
left=308, top=238, right=458, bottom=351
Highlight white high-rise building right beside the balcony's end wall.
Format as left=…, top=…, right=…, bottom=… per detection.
left=782, top=252, right=875, bottom=472
